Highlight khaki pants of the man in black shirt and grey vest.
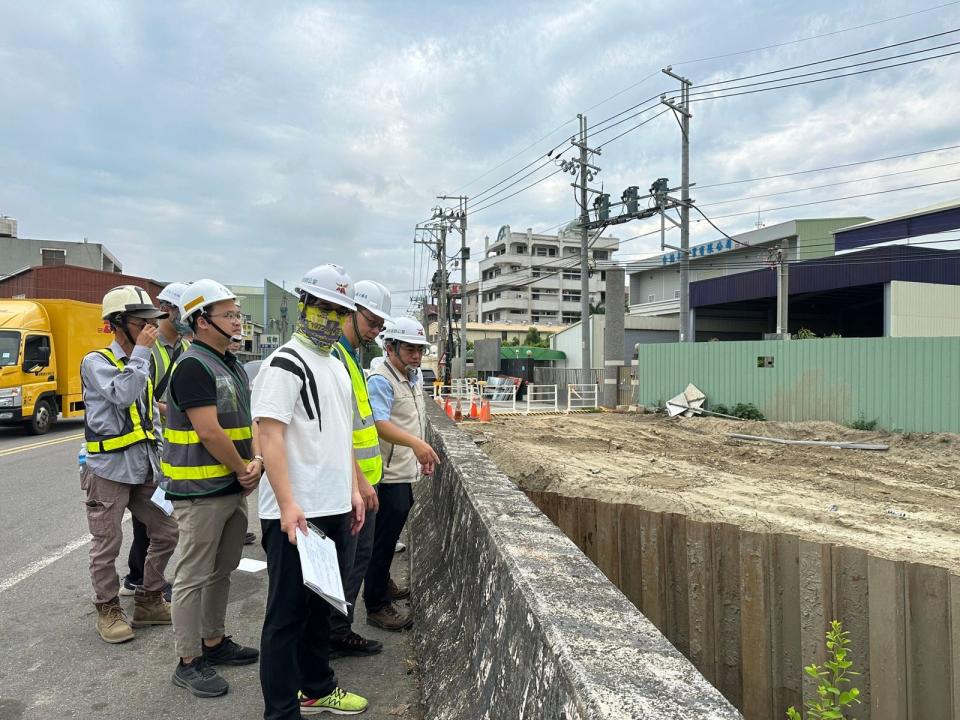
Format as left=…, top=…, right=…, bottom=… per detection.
left=172, top=493, right=247, bottom=657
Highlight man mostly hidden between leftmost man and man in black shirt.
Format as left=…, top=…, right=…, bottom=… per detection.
left=120, top=282, right=192, bottom=602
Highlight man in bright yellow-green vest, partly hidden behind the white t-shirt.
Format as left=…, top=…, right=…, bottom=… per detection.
left=330, top=280, right=391, bottom=657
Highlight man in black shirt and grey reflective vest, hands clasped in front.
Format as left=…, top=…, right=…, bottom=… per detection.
left=162, top=279, right=263, bottom=697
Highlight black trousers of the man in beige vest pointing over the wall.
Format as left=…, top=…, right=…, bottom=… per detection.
left=363, top=481, right=413, bottom=612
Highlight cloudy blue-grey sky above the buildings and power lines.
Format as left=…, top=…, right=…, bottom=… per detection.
left=0, top=0, right=960, bottom=316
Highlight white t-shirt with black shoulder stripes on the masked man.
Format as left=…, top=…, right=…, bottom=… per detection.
left=252, top=338, right=353, bottom=520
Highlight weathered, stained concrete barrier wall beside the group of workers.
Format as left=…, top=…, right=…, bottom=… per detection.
left=409, top=403, right=741, bottom=720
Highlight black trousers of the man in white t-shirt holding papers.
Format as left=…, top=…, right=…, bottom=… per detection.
left=260, top=513, right=350, bottom=720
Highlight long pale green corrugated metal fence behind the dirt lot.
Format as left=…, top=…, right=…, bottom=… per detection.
left=637, top=337, right=960, bottom=432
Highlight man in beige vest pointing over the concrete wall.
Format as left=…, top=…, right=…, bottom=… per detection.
left=363, top=317, right=439, bottom=631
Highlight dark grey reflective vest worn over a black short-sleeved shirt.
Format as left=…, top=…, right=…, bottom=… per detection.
left=160, top=343, right=253, bottom=497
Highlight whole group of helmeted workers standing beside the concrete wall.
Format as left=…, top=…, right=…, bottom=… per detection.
left=81, top=264, right=438, bottom=720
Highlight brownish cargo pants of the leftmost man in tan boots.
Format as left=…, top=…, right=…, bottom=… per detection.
left=80, top=468, right=177, bottom=603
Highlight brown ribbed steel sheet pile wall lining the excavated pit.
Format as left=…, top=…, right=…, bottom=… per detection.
left=527, top=492, right=960, bottom=720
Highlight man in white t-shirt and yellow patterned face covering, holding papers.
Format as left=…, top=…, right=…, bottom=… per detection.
left=252, top=265, right=367, bottom=720
